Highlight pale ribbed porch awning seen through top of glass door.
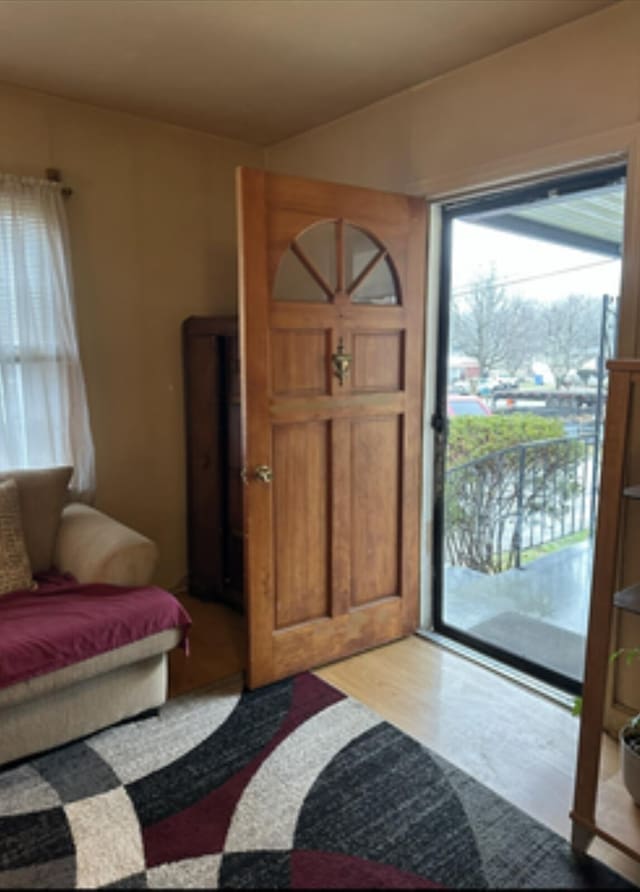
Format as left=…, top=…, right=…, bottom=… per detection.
left=465, top=180, right=625, bottom=257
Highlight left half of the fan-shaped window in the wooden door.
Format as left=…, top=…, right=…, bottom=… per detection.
left=273, top=222, right=337, bottom=303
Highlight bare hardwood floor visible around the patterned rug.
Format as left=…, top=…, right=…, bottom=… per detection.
left=169, top=596, right=640, bottom=885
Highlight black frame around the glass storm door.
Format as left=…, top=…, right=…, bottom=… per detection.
left=423, top=155, right=629, bottom=694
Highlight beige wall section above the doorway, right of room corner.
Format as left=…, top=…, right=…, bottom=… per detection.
left=266, top=0, right=640, bottom=193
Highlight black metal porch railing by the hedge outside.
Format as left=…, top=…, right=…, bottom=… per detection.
left=444, top=433, right=597, bottom=573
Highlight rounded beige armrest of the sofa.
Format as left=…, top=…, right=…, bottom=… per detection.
left=54, top=502, right=158, bottom=585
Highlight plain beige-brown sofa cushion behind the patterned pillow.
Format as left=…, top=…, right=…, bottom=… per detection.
left=0, top=467, right=73, bottom=573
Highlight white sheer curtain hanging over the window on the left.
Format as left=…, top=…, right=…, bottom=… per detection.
left=0, top=174, right=95, bottom=499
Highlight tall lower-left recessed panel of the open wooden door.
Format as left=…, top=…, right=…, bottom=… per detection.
left=273, top=422, right=330, bottom=629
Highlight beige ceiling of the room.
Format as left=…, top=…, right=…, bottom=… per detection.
left=0, top=0, right=615, bottom=145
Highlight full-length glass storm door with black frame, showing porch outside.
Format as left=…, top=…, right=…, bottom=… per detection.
left=433, top=167, right=625, bottom=691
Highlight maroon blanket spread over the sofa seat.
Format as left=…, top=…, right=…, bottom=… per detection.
left=0, top=576, right=191, bottom=688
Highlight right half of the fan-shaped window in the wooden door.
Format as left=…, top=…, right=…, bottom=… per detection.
left=344, top=225, right=398, bottom=305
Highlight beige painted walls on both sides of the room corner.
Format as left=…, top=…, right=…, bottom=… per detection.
left=5, top=0, right=640, bottom=712
